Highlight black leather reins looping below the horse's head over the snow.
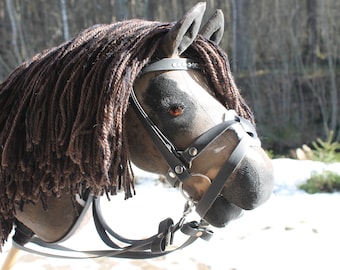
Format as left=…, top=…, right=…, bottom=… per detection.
left=13, top=196, right=213, bottom=259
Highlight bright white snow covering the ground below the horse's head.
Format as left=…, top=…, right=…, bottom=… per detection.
left=0, top=159, right=340, bottom=270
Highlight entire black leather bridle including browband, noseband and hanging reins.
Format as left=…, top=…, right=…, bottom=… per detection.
left=13, top=58, right=258, bottom=259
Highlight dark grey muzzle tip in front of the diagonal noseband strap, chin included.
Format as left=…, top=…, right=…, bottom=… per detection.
left=201, top=144, right=273, bottom=227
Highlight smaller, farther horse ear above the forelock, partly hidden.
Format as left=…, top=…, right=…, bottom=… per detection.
left=200, top=9, right=224, bottom=44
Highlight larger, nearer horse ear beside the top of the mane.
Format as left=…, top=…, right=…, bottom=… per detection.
left=161, top=2, right=206, bottom=57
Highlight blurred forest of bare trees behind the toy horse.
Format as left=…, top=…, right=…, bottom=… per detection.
left=0, top=0, right=340, bottom=153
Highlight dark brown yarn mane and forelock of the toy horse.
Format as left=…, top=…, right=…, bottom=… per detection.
left=0, top=20, right=253, bottom=248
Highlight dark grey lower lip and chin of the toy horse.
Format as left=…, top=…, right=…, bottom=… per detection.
left=204, top=196, right=243, bottom=228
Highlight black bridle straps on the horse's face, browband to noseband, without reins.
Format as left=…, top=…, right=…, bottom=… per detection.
left=131, top=58, right=259, bottom=218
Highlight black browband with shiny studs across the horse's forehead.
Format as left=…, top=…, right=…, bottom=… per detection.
left=139, top=58, right=200, bottom=76
